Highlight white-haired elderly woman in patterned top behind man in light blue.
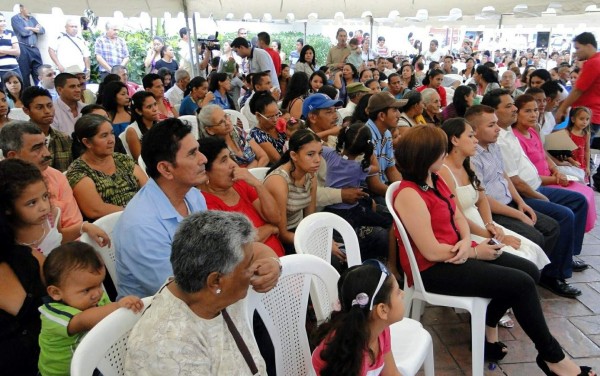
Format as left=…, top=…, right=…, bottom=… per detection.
left=197, top=104, right=269, bottom=168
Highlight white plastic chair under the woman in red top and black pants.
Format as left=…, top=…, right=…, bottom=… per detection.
left=385, top=182, right=490, bottom=376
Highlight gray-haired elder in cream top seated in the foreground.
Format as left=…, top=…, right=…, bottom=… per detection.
left=125, top=211, right=277, bottom=375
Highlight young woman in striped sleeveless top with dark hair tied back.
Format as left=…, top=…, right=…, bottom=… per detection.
left=264, top=129, right=322, bottom=254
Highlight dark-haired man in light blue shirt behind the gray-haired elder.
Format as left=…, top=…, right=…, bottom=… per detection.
left=113, top=119, right=208, bottom=297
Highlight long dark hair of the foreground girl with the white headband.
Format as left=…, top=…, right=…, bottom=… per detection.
left=316, top=265, right=394, bottom=376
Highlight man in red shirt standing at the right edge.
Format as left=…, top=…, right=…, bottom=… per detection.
left=555, top=32, right=600, bottom=189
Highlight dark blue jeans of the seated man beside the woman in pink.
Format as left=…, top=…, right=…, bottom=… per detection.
left=525, top=187, right=587, bottom=279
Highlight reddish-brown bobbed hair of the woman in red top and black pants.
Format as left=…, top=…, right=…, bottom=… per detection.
left=394, top=125, right=448, bottom=186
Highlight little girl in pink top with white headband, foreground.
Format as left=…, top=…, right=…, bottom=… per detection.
left=312, top=259, right=404, bottom=376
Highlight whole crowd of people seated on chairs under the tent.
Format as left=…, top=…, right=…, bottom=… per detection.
left=0, top=15, right=600, bottom=375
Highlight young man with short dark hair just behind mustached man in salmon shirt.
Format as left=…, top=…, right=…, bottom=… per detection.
left=21, top=86, right=73, bottom=172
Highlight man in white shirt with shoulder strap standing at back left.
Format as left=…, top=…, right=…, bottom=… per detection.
left=48, top=18, right=90, bottom=79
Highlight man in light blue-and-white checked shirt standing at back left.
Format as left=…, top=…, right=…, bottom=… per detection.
left=94, top=22, right=129, bottom=80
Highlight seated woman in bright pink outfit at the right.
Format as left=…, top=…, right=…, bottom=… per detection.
left=513, top=94, right=596, bottom=232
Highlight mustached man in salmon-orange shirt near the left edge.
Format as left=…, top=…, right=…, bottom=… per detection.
left=0, top=120, right=108, bottom=245
